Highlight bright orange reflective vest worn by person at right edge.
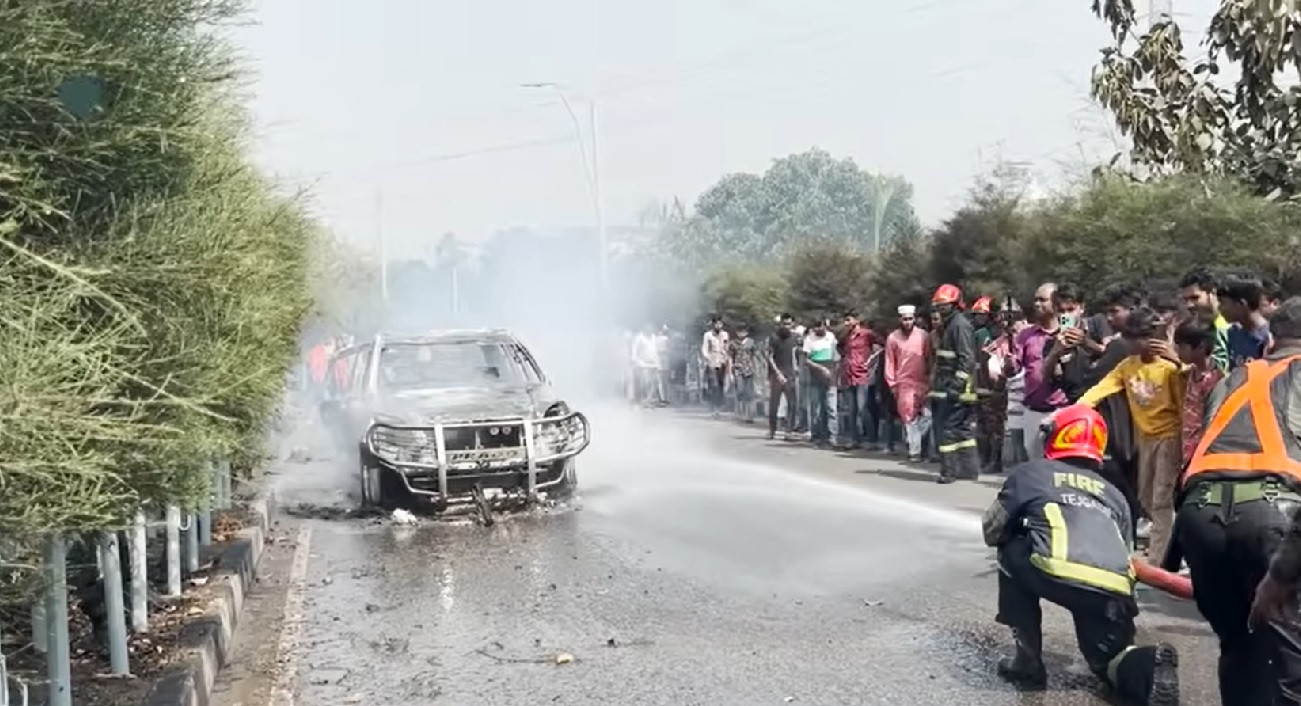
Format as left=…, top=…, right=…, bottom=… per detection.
left=1180, top=355, right=1301, bottom=489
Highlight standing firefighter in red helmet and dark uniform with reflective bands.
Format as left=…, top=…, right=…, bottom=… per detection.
left=930, top=285, right=980, bottom=484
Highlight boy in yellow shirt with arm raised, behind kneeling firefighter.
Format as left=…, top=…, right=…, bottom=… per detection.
left=1080, top=307, right=1184, bottom=562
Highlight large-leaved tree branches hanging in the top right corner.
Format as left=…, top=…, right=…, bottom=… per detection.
left=1093, top=0, right=1301, bottom=198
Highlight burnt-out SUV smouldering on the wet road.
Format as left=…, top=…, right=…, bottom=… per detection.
left=321, top=330, right=591, bottom=510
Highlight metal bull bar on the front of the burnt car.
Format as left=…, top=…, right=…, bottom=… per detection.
left=366, top=412, right=591, bottom=501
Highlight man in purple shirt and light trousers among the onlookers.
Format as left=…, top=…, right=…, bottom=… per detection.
left=1008, top=282, right=1067, bottom=459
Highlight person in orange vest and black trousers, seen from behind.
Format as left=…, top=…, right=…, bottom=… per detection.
left=1164, top=298, right=1301, bottom=706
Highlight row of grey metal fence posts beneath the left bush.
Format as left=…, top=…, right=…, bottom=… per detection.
left=0, top=460, right=233, bottom=706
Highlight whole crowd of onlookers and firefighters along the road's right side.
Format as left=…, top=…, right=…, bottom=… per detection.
left=627, top=268, right=1301, bottom=706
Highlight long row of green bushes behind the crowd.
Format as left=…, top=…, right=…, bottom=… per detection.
left=686, top=173, right=1301, bottom=327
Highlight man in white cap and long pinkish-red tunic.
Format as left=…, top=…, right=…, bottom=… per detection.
left=885, top=304, right=930, bottom=462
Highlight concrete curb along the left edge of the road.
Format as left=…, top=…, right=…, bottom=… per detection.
left=144, top=488, right=276, bottom=706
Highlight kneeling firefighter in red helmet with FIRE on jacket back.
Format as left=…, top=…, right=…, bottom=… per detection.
left=984, top=404, right=1179, bottom=706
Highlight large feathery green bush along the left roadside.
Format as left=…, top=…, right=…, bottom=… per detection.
left=0, top=0, right=317, bottom=608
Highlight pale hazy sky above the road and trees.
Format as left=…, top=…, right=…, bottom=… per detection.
left=239, top=0, right=1214, bottom=260
